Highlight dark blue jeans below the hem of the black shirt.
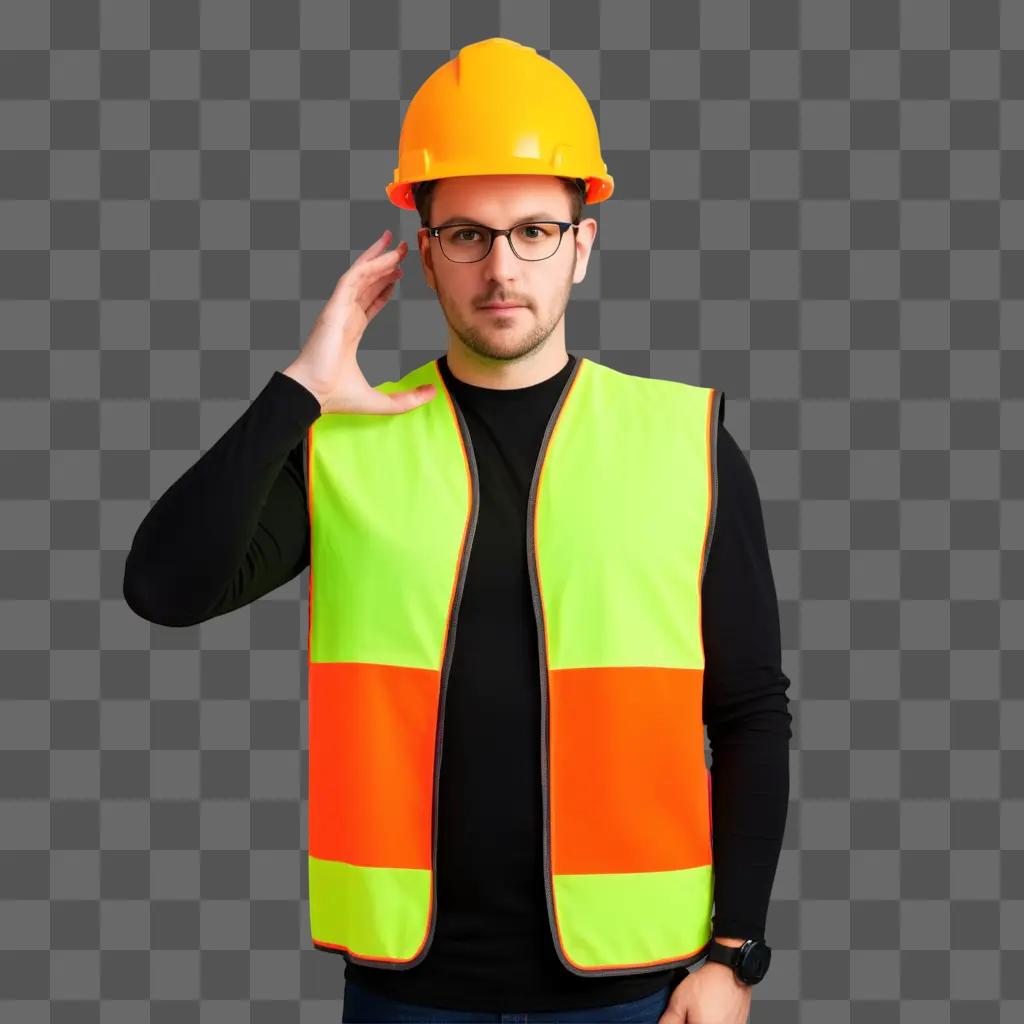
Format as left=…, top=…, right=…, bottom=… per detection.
left=341, top=981, right=676, bottom=1024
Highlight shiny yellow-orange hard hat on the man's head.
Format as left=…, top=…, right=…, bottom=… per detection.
left=385, top=36, right=614, bottom=210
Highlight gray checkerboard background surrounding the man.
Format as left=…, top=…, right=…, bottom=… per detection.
left=0, top=0, right=1024, bottom=1024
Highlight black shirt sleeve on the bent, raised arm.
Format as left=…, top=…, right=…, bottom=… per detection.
left=123, top=371, right=321, bottom=627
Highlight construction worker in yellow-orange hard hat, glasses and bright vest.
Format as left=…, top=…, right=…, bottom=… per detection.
left=124, top=38, right=792, bottom=1024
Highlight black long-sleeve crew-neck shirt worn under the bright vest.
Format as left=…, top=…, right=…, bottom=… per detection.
left=124, top=354, right=792, bottom=1011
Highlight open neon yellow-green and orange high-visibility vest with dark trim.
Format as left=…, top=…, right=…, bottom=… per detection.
left=305, top=357, right=724, bottom=976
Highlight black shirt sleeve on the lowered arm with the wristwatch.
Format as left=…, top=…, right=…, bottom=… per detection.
left=701, top=415, right=793, bottom=939
